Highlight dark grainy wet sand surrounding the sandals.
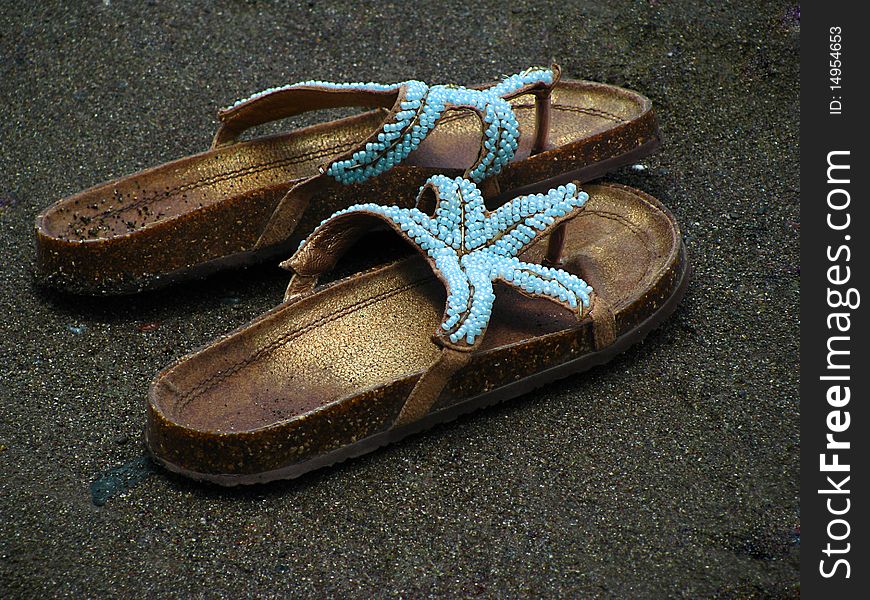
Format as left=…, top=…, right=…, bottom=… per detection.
left=0, top=0, right=800, bottom=598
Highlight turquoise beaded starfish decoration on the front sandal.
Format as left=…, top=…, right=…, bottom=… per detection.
left=300, top=175, right=592, bottom=346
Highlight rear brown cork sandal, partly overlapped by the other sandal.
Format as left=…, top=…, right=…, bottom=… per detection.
left=36, top=66, right=659, bottom=294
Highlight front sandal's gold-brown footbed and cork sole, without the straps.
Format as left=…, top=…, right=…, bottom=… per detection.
left=146, top=184, right=686, bottom=481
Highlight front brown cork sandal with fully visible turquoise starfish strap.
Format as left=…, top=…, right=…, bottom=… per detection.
left=146, top=176, right=688, bottom=485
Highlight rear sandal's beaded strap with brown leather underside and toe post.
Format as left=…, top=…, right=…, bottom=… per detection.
left=212, top=65, right=561, bottom=185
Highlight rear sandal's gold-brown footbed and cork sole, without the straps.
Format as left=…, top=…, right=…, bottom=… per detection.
left=36, top=80, right=659, bottom=294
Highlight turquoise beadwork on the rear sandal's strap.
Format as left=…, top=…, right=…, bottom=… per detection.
left=230, top=68, right=555, bottom=184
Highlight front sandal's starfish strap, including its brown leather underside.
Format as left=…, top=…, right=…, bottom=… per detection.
left=282, top=175, right=592, bottom=352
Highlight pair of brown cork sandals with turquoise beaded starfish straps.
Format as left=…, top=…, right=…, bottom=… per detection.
left=36, top=65, right=688, bottom=485
